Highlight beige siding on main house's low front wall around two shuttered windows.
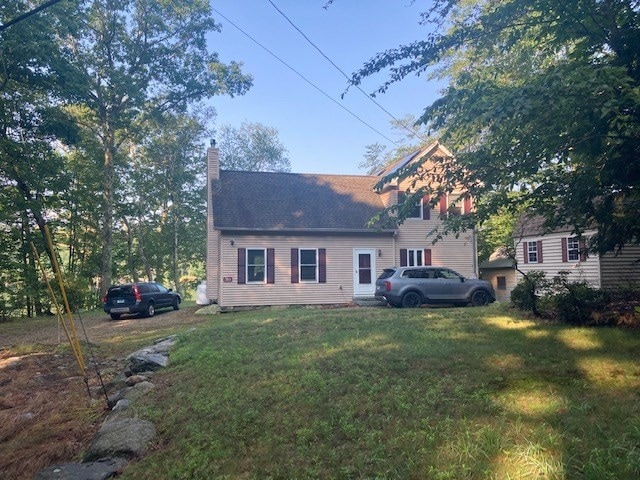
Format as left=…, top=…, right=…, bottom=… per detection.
left=218, top=234, right=393, bottom=307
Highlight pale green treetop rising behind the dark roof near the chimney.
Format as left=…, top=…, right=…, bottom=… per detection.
left=220, top=122, right=291, bottom=172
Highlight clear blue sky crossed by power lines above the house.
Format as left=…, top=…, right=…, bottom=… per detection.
left=209, top=0, right=441, bottom=174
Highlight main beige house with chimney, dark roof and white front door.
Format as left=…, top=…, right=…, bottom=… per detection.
left=206, top=142, right=478, bottom=308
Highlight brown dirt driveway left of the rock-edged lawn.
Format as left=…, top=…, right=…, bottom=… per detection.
left=0, top=307, right=209, bottom=480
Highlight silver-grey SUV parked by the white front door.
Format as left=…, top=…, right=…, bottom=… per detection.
left=376, top=267, right=496, bottom=308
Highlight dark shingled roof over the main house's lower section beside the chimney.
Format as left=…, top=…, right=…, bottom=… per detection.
left=212, top=170, right=392, bottom=232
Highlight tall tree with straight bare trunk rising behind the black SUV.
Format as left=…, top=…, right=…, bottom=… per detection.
left=69, top=0, right=251, bottom=291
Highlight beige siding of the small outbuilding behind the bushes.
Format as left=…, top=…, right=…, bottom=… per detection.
left=516, top=233, right=600, bottom=288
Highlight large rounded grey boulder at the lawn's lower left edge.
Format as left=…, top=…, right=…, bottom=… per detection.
left=84, top=418, right=156, bottom=462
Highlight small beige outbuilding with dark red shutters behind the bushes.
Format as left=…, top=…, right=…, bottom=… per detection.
left=514, top=214, right=640, bottom=290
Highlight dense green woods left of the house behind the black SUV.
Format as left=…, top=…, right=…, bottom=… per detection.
left=0, top=0, right=251, bottom=318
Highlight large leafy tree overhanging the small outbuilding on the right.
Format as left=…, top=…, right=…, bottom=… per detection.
left=348, top=0, right=640, bottom=252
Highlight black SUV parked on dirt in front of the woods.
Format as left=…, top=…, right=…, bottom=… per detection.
left=102, top=282, right=182, bottom=320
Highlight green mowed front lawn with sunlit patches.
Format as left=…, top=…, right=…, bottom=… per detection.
left=123, top=305, right=640, bottom=480
